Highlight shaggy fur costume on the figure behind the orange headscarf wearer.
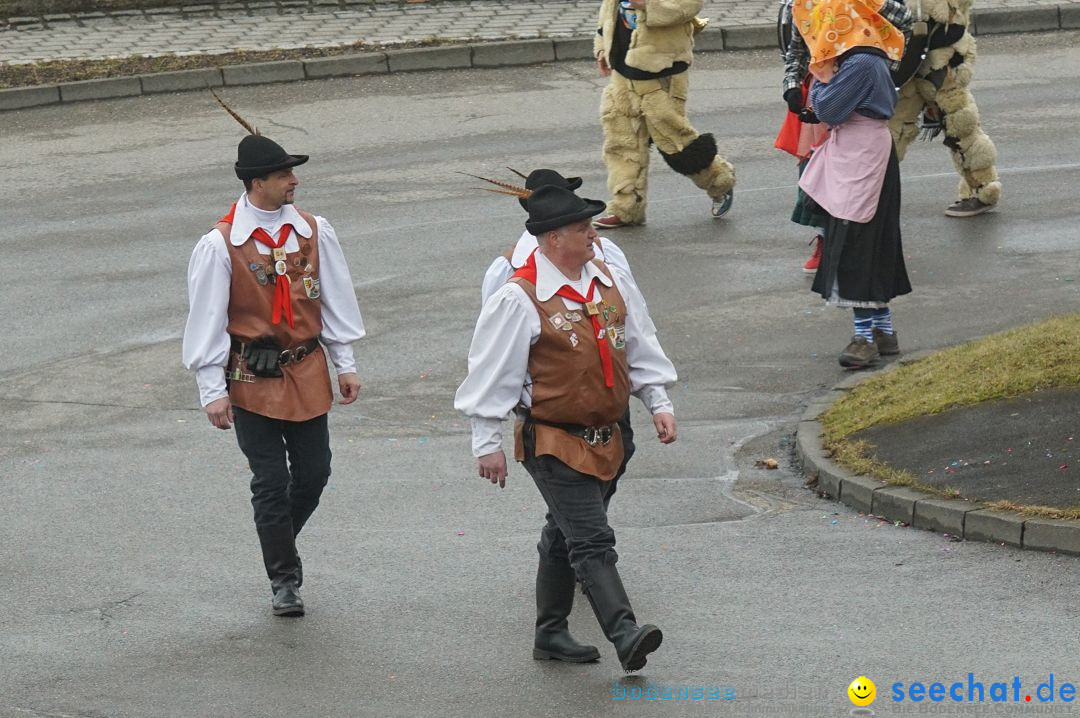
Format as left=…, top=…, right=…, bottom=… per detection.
left=889, top=0, right=1001, bottom=206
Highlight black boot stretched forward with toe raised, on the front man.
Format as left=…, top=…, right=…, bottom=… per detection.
left=583, top=561, right=664, bottom=670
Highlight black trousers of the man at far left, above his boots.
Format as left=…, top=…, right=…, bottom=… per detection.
left=232, top=407, right=330, bottom=536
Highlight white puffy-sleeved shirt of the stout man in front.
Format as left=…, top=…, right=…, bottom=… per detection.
left=454, top=255, right=678, bottom=457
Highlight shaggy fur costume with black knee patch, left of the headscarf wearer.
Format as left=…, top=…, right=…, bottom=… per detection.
left=594, top=0, right=735, bottom=225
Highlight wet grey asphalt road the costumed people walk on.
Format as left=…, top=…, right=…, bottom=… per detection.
left=0, top=33, right=1080, bottom=718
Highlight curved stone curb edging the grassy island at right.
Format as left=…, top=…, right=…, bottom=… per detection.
left=795, top=351, right=1080, bottom=556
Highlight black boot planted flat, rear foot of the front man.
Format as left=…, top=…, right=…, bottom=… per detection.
left=532, top=556, right=600, bottom=663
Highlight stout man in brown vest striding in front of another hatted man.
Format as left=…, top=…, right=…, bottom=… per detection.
left=455, top=186, right=676, bottom=670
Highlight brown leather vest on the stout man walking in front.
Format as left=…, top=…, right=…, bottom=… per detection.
left=510, top=260, right=630, bottom=482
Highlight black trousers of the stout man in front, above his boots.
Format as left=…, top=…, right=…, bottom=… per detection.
left=522, top=410, right=634, bottom=580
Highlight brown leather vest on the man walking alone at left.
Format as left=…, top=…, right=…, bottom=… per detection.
left=217, top=211, right=334, bottom=421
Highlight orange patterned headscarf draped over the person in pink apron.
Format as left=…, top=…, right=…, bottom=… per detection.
left=792, top=0, right=904, bottom=82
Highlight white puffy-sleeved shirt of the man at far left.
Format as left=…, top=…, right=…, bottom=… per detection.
left=183, top=210, right=365, bottom=406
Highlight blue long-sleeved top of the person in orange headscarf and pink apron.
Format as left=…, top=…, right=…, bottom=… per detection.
left=810, top=51, right=896, bottom=126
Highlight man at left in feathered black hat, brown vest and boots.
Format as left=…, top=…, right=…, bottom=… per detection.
left=184, top=134, right=364, bottom=615
